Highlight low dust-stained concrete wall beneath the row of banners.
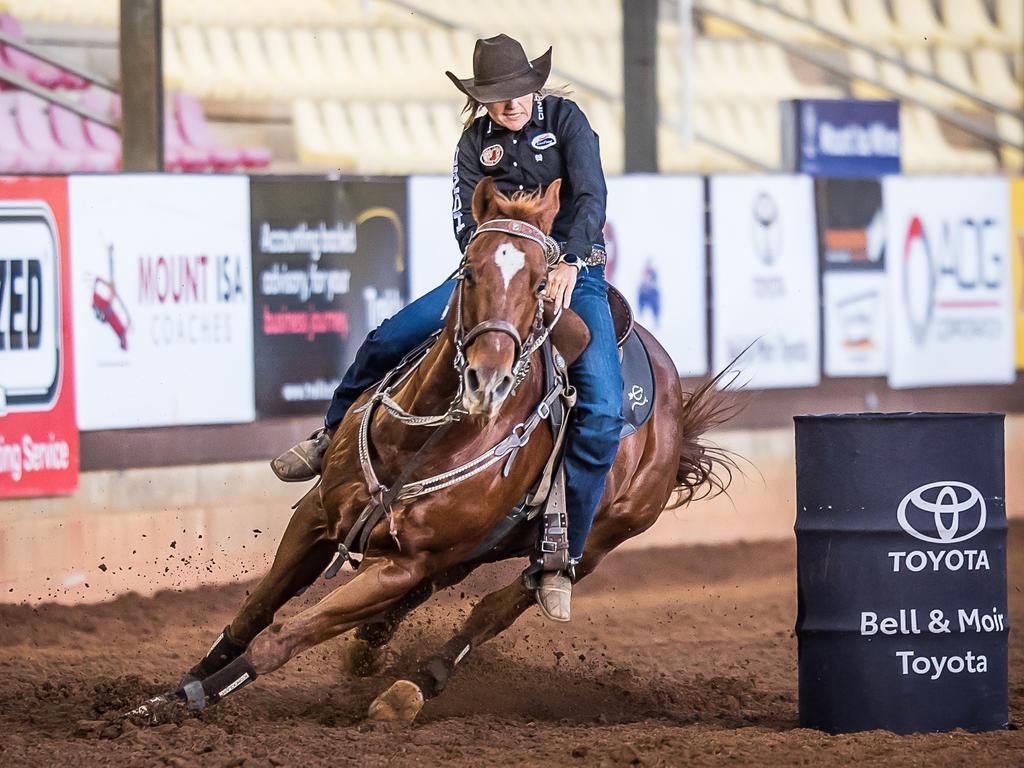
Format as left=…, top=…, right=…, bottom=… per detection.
left=0, top=416, right=1024, bottom=603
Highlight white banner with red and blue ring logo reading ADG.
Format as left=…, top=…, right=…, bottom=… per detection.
left=883, top=176, right=1014, bottom=387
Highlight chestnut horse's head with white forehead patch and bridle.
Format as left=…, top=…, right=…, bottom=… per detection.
left=454, top=176, right=561, bottom=418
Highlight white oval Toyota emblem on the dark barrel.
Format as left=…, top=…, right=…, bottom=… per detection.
left=896, top=480, right=985, bottom=544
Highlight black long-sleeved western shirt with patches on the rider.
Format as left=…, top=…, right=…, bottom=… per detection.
left=452, top=96, right=607, bottom=259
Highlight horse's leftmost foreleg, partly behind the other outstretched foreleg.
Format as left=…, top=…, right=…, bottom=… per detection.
left=180, top=494, right=335, bottom=680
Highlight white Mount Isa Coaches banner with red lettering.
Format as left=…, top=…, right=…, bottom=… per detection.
left=69, top=175, right=255, bottom=430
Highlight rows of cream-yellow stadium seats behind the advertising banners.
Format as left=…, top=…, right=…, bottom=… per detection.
left=0, top=0, right=1024, bottom=173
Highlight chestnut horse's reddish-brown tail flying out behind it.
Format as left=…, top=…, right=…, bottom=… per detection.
left=668, top=365, right=742, bottom=509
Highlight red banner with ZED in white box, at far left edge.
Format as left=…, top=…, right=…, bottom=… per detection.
left=0, top=177, right=79, bottom=498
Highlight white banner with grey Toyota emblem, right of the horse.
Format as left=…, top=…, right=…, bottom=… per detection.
left=711, top=175, right=820, bottom=389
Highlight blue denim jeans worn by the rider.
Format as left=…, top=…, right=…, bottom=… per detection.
left=326, top=267, right=623, bottom=560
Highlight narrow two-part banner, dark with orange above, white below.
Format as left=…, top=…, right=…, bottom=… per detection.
left=816, top=179, right=888, bottom=377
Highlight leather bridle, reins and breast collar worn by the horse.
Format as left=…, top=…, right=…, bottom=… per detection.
left=326, top=219, right=575, bottom=578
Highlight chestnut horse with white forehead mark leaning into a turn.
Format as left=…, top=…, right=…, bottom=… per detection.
left=135, top=177, right=727, bottom=722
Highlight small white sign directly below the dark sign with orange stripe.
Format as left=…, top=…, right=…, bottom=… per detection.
left=821, top=269, right=889, bottom=377
